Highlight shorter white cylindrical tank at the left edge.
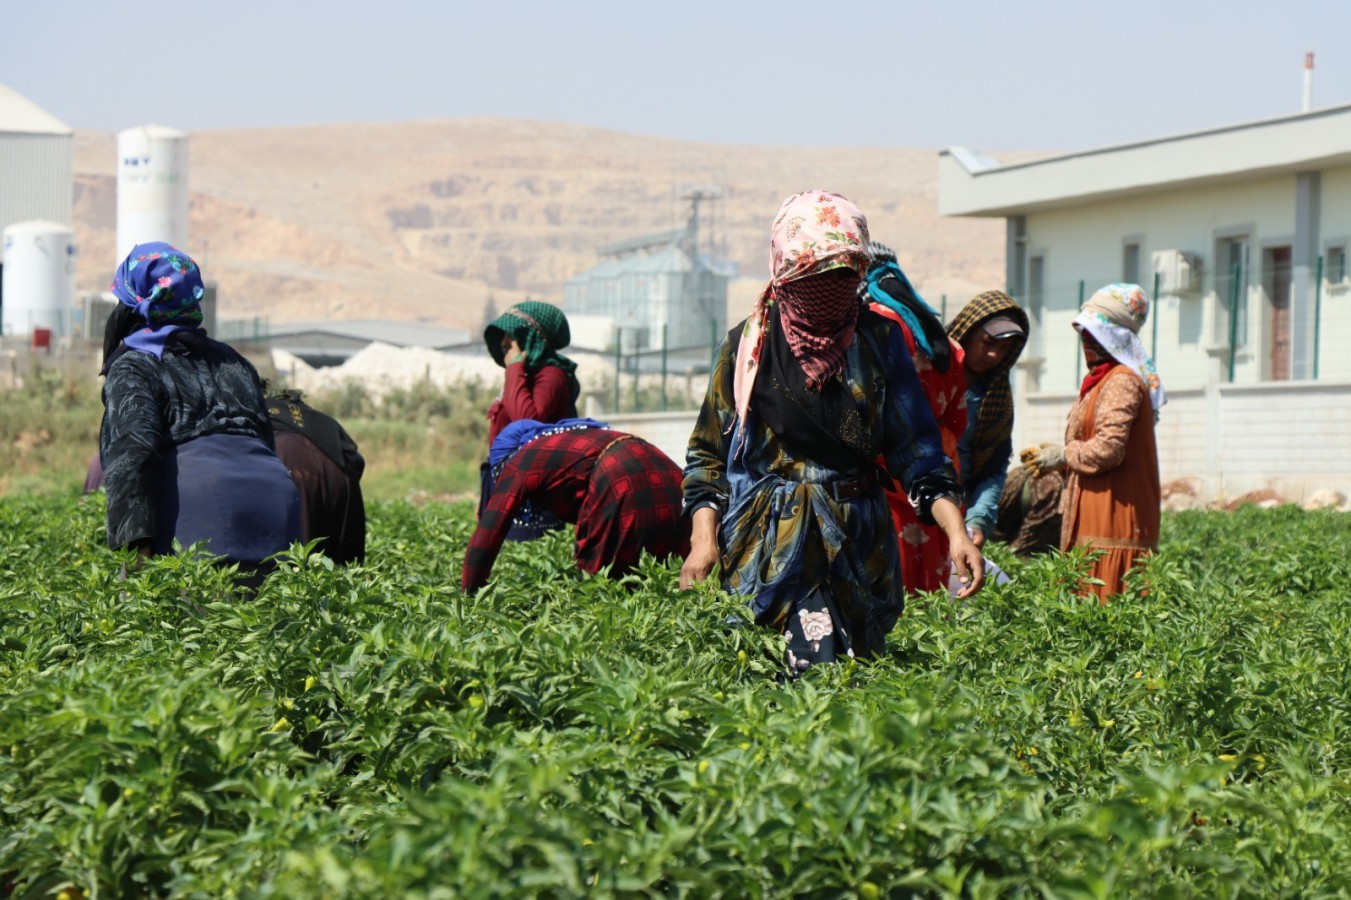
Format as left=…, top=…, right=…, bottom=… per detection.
left=0, top=219, right=76, bottom=336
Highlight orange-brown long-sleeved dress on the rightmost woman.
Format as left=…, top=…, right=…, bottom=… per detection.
left=1061, top=365, right=1161, bottom=603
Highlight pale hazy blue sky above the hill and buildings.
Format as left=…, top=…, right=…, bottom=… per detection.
left=0, top=0, right=1351, bottom=150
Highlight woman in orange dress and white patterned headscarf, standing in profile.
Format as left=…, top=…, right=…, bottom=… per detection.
left=1020, top=284, right=1166, bottom=603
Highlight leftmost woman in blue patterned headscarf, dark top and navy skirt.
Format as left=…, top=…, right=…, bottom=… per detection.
left=99, top=243, right=300, bottom=580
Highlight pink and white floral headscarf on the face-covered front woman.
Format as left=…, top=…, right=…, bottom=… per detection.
left=732, top=191, right=871, bottom=422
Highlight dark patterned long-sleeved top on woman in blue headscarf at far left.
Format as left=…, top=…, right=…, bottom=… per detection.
left=99, top=332, right=274, bottom=549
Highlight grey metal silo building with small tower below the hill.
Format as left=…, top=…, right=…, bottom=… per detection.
left=563, top=191, right=728, bottom=362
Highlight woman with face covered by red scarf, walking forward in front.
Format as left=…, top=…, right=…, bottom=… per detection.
left=681, top=191, right=985, bottom=672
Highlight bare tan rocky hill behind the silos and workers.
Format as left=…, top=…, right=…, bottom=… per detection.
left=76, top=119, right=1004, bottom=327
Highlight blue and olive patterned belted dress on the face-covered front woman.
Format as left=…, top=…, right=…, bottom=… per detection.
left=684, top=314, right=957, bottom=669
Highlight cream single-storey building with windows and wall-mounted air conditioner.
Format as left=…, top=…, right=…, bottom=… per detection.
left=939, top=105, right=1351, bottom=500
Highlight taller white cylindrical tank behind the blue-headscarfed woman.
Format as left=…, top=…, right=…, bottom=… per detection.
left=113, top=126, right=190, bottom=265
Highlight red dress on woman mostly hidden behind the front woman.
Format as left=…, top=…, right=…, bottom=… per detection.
left=869, top=303, right=966, bottom=595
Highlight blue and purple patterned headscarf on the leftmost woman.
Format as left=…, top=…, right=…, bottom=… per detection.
left=111, top=241, right=205, bottom=358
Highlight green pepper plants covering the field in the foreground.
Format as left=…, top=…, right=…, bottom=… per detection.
left=0, top=499, right=1351, bottom=897
